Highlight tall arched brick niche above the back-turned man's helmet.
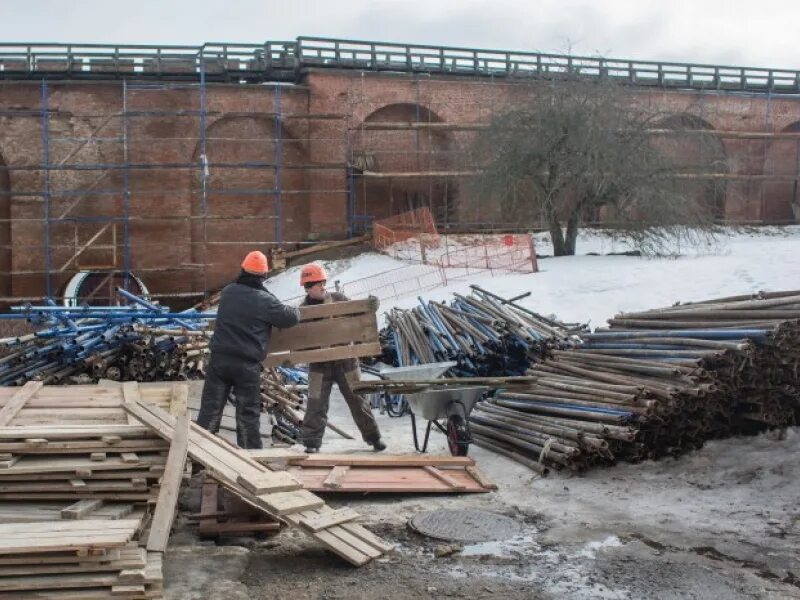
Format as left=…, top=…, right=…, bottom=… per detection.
left=191, top=115, right=314, bottom=289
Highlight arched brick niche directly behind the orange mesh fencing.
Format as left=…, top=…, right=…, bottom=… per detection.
left=348, top=103, right=458, bottom=223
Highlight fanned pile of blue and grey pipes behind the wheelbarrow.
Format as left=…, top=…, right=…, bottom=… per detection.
left=381, top=285, right=582, bottom=377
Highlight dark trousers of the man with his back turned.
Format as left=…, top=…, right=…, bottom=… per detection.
left=197, top=354, right=262, bottom=448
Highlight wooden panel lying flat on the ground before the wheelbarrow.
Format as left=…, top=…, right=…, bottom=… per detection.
left=250, top=448, right=497, bottom=493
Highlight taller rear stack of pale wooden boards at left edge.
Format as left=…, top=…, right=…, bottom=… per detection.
left=0, top=382, right=172, bottom=502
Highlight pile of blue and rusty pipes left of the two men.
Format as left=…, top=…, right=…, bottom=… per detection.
left=0, top=289, right=215, bottom=385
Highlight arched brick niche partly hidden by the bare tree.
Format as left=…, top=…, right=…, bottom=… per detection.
left=654, top=113, right=730, bottom=219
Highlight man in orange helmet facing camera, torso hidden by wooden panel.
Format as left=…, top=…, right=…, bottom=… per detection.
left=300, top=263, right=386, bottom=453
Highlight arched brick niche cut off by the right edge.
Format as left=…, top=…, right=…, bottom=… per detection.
left=761, top=121, right=800, bottom=223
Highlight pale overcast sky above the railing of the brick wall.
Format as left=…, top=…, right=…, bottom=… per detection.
left=6, top=0, right=800, bottom=70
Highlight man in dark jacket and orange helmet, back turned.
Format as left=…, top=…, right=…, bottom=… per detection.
left=197, top=251, right=300, bottom=448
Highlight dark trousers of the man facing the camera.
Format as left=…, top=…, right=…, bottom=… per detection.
left=301, top=361, right=381, bottom=448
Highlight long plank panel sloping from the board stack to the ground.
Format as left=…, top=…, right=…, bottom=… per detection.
left=124, top=383, right=391, bottom=566
